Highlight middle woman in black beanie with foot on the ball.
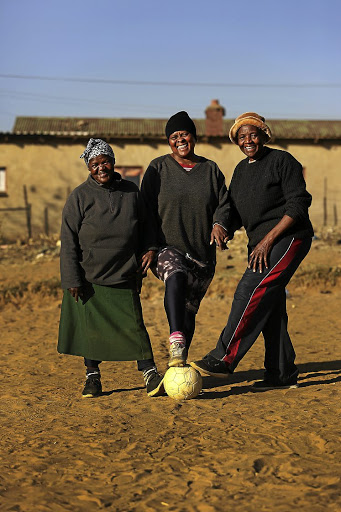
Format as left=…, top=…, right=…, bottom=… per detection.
left=141, top=111, right=229, bottom=366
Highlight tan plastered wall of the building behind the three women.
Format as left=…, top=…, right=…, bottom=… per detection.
left=0, top=137, right=341, bottom=240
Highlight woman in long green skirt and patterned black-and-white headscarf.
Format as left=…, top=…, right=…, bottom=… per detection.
left=58, top=139, right=164, bottom=397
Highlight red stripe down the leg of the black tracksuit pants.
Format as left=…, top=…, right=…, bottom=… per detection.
left=223, top=239, right=302, bottom=364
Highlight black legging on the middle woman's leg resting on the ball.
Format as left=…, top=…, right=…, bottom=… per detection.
left=164, top=272, right=195, bottom=350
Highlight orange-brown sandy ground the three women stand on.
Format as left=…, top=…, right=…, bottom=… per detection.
left=0, top=233, right=341, bottom=512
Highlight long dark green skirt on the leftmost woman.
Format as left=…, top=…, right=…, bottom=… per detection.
left=58, top=284, right=153, bottom=361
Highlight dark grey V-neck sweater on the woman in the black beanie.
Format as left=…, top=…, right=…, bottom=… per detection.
left=141, top=155, right=229, bottom=263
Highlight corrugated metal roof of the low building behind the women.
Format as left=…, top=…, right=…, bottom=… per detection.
left=12, top=117, right=341, bottom=140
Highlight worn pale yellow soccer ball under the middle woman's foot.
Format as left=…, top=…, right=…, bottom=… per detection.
left=163, top=365, right=202, bottom=400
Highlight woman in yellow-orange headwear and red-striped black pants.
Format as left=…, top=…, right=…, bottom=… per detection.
left=191, top=112, right=313, bottom=390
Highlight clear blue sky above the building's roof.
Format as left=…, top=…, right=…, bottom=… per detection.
left=0, top=0, right=341, bottom=131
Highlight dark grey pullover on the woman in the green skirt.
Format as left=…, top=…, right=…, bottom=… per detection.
left=60, top=174, right=147, bottom=288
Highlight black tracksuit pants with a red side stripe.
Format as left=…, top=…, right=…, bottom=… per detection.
left=210, top=236, right=311, bottom=384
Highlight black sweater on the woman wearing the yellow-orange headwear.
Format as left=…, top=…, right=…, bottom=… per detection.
left=229, top=147, right=314, bottom=248
